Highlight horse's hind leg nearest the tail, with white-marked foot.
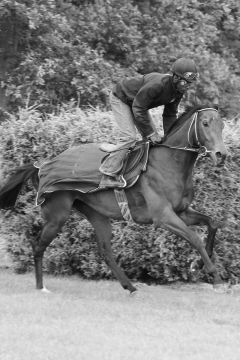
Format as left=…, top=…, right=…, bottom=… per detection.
left=32, top=192, right=73, bottom=289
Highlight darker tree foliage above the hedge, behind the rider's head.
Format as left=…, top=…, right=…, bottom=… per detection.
left=0, top=0, right=240, bottom=115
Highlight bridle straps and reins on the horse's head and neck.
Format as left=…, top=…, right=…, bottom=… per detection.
left=160, top=108, right=217, bottom=156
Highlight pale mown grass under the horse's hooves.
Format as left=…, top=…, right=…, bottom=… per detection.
left=0, top=270, right=240, bottom=360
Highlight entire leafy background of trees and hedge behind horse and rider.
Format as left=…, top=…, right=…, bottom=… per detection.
left=0, top=0, right=240, bottom=283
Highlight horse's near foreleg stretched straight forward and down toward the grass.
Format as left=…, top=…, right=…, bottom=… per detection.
left=157, top=209, right=222, bottom=284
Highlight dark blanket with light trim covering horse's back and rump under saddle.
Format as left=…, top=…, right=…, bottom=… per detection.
left=35, top=143, right=149, bottom=205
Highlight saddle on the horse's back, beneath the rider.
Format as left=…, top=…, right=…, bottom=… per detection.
left=99, top=141, right=149, bottom=188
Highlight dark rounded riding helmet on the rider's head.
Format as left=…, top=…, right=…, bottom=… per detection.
left=172, top=58, right=199, bottom=82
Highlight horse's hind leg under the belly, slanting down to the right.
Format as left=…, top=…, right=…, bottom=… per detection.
left=75, top=204, right=136, bottom=293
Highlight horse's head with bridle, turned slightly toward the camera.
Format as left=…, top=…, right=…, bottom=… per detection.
left=193, top=108, right=227, bottom=165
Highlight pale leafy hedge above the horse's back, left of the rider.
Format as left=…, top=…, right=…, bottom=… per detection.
left=0, top=103, right=115, bottom=173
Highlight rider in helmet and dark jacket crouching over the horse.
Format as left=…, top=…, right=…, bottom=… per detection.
left=100, top=58, right=198, bottom=187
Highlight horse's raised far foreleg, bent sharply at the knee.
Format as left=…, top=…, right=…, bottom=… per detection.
left=179, top=207, right=221, bottom=269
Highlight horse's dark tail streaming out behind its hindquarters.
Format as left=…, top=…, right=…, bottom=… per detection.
left=0, top=164, right=38, bottom=209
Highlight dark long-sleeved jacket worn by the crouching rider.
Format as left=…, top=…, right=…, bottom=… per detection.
left=113, top=73, right=183, bottom=137
